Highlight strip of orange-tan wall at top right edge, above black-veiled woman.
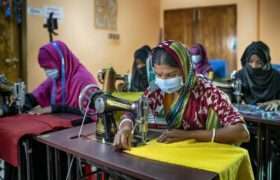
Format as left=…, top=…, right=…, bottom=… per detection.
left=260, top=0, right=280, bottom=64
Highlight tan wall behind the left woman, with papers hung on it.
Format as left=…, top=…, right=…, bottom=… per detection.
left=27, top=0, right=160, bottom=91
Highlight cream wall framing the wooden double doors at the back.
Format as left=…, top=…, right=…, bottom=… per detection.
left=160, top=0, right=258, bottom=67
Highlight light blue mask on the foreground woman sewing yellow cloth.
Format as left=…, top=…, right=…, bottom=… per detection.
left=155, top=76, right=184, bottom=93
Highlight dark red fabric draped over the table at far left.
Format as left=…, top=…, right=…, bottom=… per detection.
left=0, top=114, right=73, bottom=166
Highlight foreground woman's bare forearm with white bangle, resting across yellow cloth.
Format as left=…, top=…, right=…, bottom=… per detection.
left=187, top=123, right=250, bottom=144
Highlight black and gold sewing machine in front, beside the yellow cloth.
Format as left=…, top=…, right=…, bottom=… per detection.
left=79, top=85, right=149, bottom=145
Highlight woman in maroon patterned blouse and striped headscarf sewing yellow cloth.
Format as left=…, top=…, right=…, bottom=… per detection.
left=114, top=41, right=249, bottom=149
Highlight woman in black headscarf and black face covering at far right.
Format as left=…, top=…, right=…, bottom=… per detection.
left=235, top=41, right=280, bottom=110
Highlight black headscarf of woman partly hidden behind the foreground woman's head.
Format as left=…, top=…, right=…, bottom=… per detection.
left=129, top=45, right=151, bottom=91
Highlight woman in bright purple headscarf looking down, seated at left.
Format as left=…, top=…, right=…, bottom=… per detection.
left=5, top=41, right=99, bottom=179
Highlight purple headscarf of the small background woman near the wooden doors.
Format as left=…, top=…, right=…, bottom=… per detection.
left=190, top=44, right=212, bottom=76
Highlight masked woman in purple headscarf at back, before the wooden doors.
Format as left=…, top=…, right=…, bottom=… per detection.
left=190, top=44, right=214, bottom=80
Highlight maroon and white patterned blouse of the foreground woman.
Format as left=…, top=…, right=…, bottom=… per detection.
left=144, top=76, right=244, bottom=129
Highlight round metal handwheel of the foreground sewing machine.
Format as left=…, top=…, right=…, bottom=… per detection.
left=79, top=84, right=100, bottom=116
